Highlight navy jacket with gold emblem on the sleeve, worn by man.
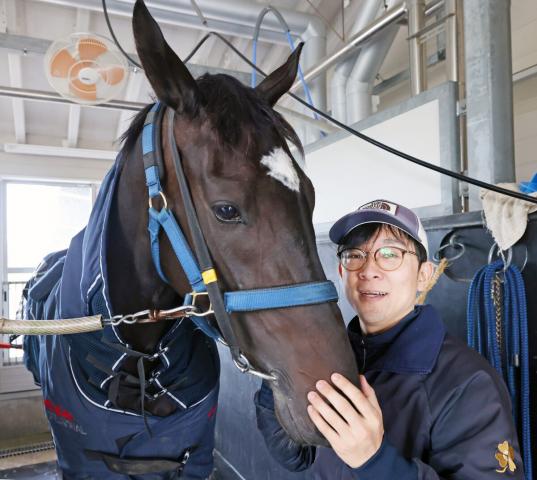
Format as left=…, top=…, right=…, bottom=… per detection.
left=255, top=305, right=524, bottom=480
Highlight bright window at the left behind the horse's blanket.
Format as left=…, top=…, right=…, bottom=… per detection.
left=0, top=181, right=93, bottom=372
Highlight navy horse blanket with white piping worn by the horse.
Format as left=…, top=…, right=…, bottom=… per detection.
left=24, top=159, right=219, bottom=480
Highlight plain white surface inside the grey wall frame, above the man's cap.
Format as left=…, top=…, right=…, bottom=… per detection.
left=306, top=100, right=442, bottom=224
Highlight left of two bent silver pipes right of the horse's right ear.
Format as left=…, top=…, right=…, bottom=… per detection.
left=329, top=0, right=383, bottom=122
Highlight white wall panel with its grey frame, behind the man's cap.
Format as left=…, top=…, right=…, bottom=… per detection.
left=305, top=82, right=459, bottom=232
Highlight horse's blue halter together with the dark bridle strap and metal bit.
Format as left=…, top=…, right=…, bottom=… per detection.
left=142, top=102, right=338, bottom=380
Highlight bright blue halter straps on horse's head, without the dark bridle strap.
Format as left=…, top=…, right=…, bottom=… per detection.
left=142, top=103, right=338, bottom=368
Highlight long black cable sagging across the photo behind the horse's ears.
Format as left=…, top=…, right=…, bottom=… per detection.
left=102, top=0, right=537, bottom=204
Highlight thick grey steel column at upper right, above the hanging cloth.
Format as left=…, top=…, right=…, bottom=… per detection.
left=463, top=0, right=515, bottom=210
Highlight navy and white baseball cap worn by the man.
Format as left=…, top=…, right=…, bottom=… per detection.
left=328, top=200, right=429, bottom=255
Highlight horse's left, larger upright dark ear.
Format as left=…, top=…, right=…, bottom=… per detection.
left=132, top=0, right=200, bottom=113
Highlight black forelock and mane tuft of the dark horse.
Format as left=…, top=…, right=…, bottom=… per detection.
left=120, top=74, right=304, bottom=156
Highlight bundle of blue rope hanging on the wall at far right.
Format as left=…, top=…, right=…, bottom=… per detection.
left=467, top=260, right=533, bottom=480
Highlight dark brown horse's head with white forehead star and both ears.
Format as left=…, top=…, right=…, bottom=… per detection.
left=129, top=0, right=357, bottom=444
